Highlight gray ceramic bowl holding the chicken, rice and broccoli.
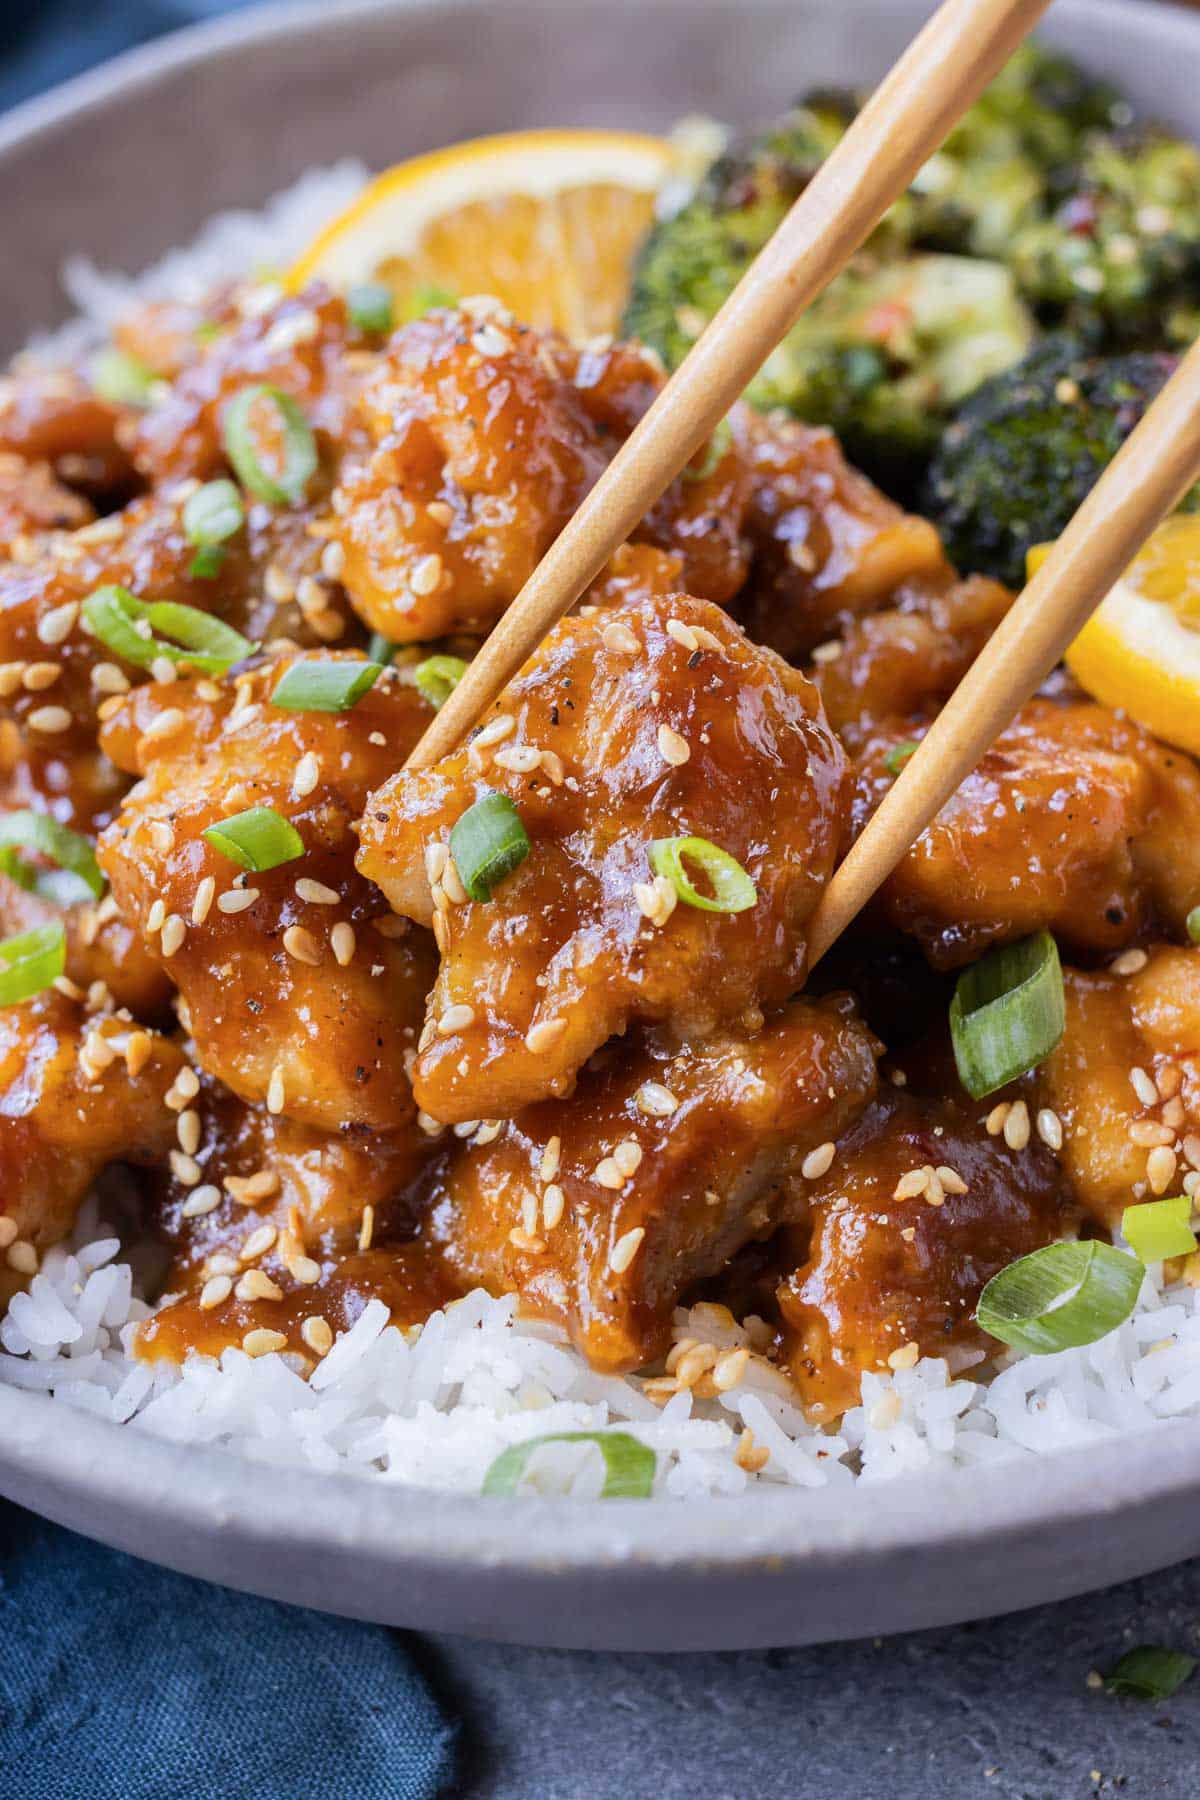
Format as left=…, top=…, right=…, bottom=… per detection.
left=0, top=0, right=1200, bottom=1651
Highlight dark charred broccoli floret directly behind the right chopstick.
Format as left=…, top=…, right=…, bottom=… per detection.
left=923, top=335, right=1177, bottom=587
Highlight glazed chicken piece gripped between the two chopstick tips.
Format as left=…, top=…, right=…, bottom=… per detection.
left=358, top=594, right=844, bottom=1121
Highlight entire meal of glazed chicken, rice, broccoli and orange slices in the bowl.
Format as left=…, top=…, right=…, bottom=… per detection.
left=0, top=35, right=1200, bottom=1499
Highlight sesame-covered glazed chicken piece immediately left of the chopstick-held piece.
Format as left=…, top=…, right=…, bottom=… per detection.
left=99, top=657, right=434, bottom=1130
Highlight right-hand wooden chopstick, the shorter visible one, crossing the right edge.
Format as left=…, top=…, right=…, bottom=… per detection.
left=808, top=340, right=1200, bottom=968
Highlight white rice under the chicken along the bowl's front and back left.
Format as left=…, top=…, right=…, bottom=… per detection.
left=9, top=162, right=1200, bottom=1499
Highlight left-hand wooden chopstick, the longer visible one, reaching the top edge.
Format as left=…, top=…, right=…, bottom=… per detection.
left=407, top=0, right=1049, bottom=769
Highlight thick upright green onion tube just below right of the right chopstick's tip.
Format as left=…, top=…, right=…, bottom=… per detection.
left=950, top=931, right=1067, bottom=1100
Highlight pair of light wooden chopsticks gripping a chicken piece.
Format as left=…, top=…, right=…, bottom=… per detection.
left=408, top=0, right=1200, bottom=968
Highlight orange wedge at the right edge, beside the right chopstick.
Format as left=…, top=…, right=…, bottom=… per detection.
left=1029, top=513, right=1200, bottom=756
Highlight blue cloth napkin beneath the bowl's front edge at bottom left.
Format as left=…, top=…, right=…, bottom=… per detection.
left=0, top=1503, right=455, bottom=1800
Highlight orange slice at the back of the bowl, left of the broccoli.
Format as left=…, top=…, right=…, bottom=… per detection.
left=288, top=131, right=675, bottom=342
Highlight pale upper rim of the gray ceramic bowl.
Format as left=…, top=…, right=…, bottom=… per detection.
left=0, top=0, right=1200, bottom=1634
